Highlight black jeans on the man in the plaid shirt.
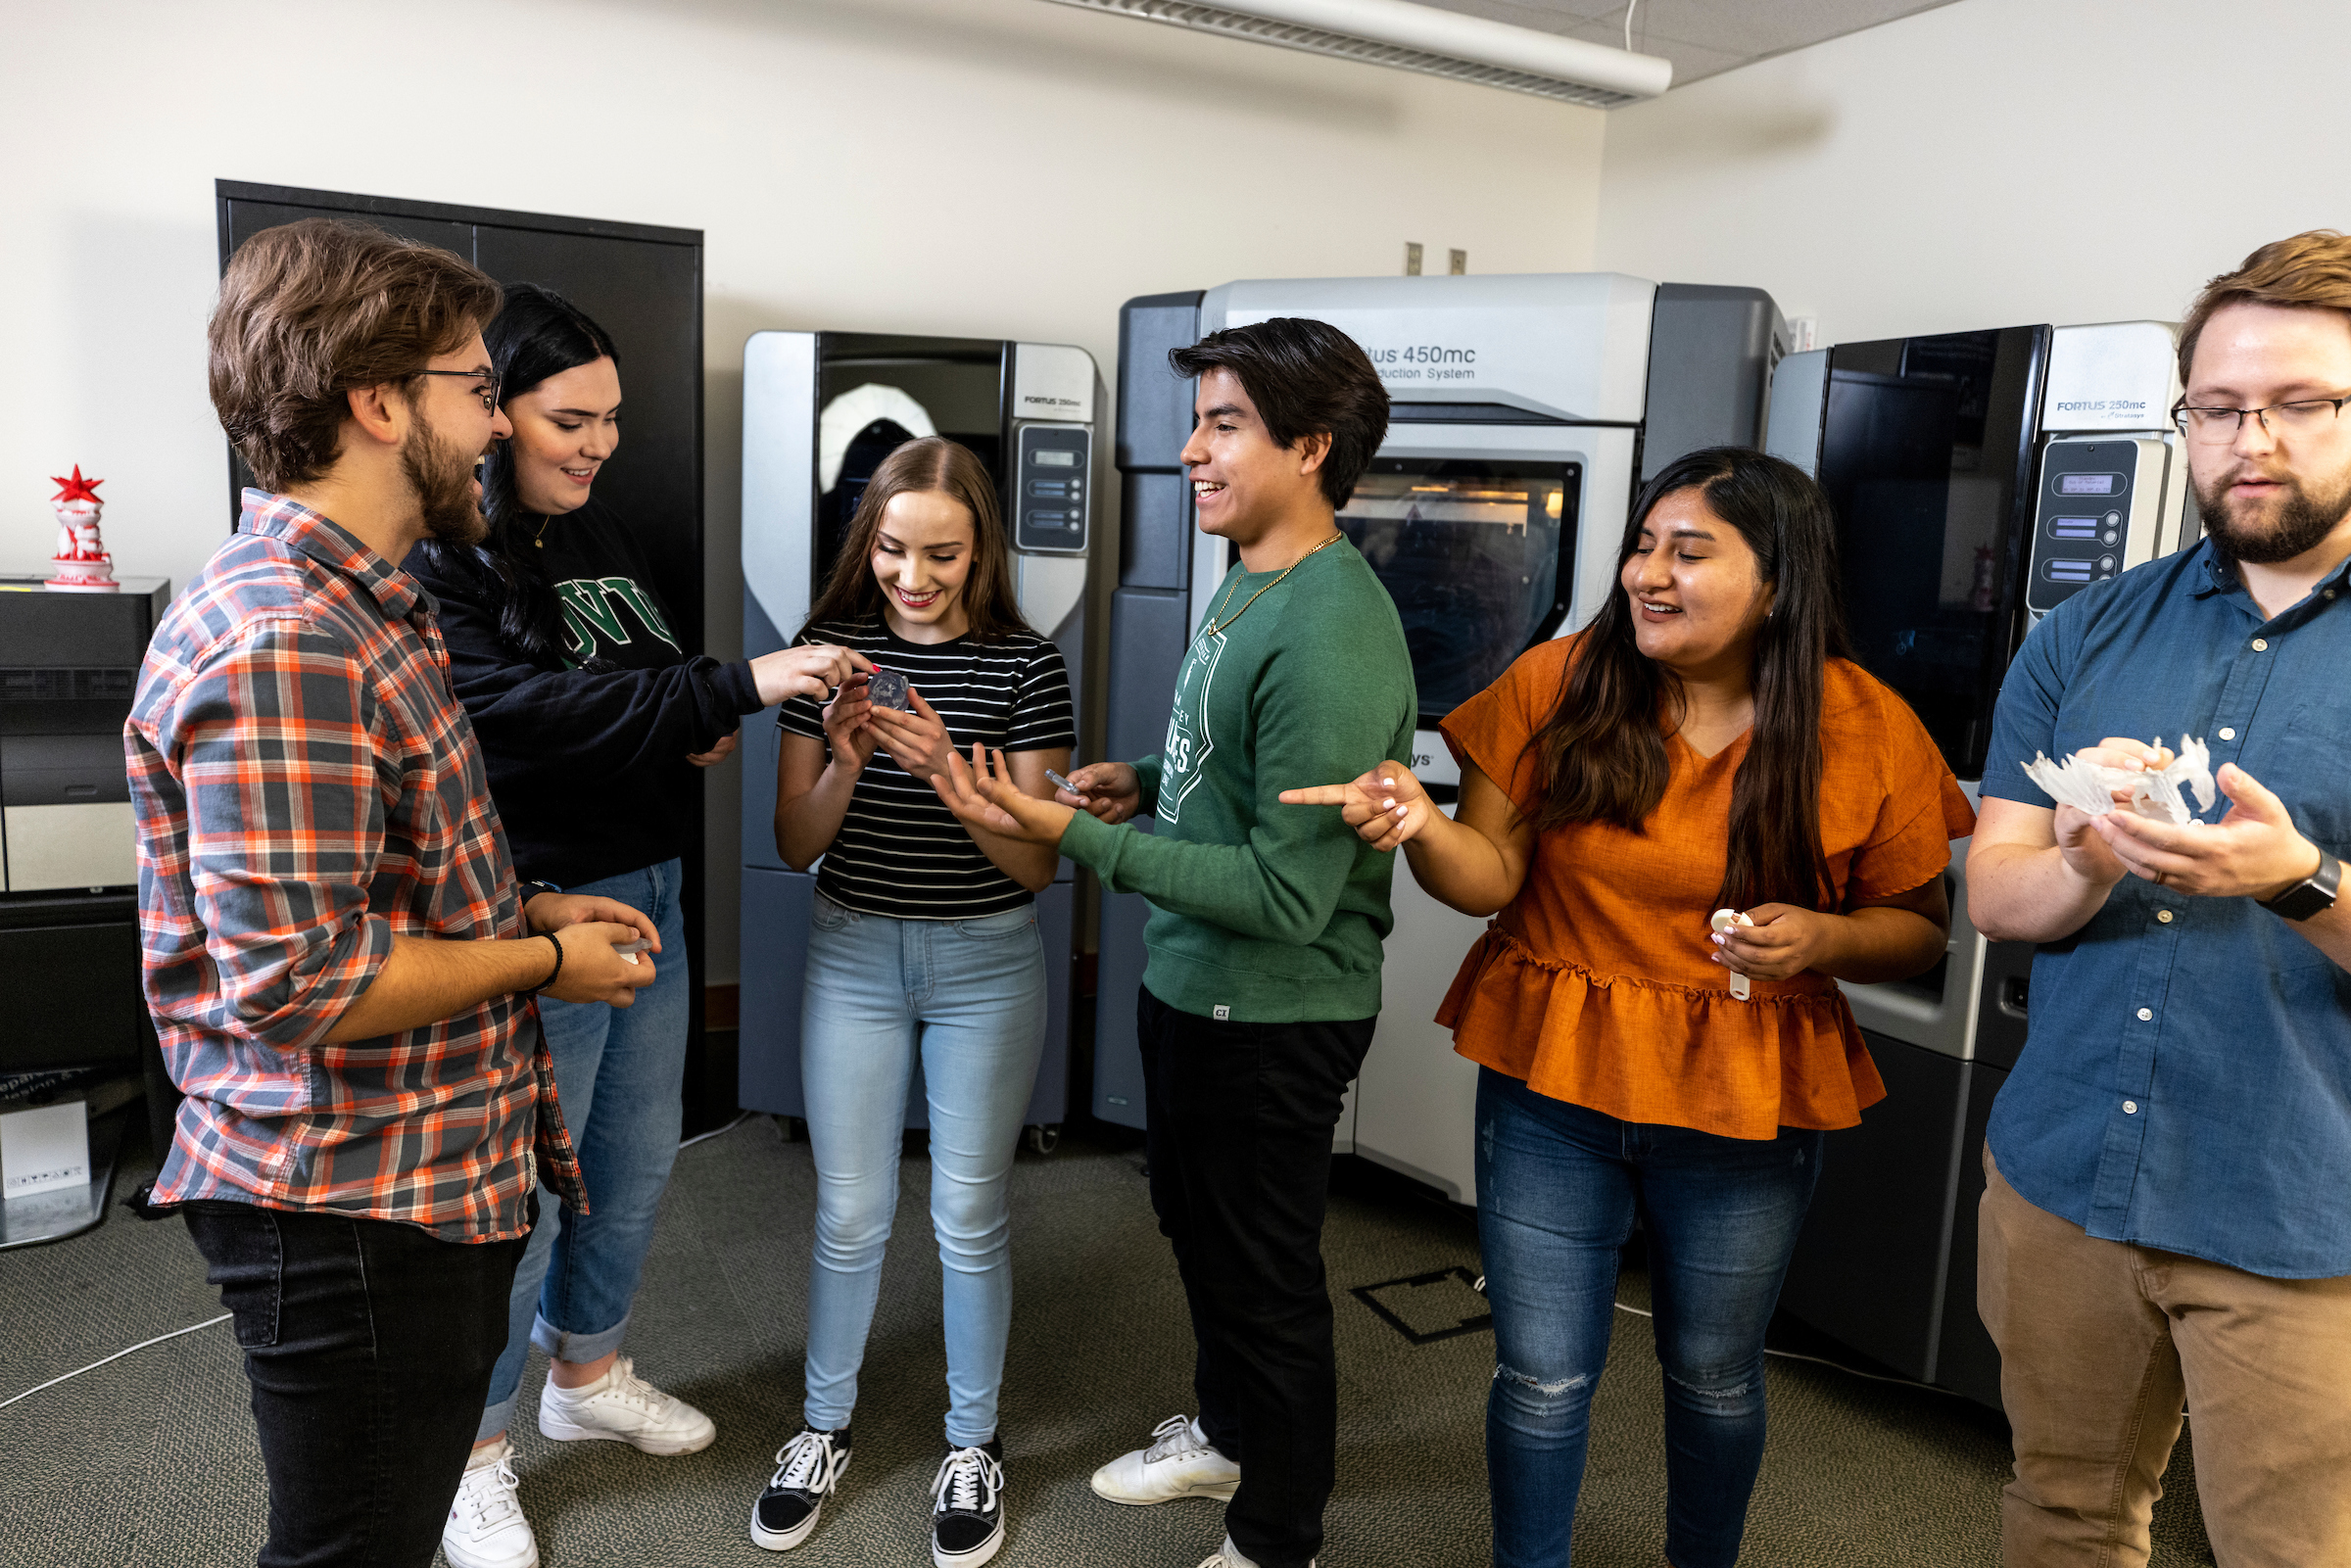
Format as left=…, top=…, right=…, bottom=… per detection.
left=181, top=1202, right=527, bottom=1568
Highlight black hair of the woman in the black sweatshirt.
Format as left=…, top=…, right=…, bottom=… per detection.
left=416, top=282, right=621, bottom=668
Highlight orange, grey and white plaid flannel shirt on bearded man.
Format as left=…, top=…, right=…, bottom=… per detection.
left=124, top=489, right=586, bottom=1241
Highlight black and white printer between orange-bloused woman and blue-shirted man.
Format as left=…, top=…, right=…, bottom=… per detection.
left=1768, top=322, right=2200, bottom=1405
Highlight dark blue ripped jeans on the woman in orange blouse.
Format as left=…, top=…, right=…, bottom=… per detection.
left=1476, top=1068, right=1822, bottom=1568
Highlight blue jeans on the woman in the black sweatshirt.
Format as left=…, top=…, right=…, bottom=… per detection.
left=475, top=861, right=694, bottom=1441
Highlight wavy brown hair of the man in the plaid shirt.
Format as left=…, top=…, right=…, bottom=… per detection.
left=205, top=218, right=501, bottom=492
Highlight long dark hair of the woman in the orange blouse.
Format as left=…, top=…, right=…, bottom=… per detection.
left=1528, top=447, right=1846, bottom=910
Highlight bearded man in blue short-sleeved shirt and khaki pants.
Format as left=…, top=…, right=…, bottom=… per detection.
left=1968, top=233, right=2351, bottom=1568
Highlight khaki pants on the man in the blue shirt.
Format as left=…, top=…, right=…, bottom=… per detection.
left=1975, top=1150, right=2351, bottom=1568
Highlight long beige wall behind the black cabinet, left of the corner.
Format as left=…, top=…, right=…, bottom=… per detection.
left=0, top=0, right=1604, bottom=980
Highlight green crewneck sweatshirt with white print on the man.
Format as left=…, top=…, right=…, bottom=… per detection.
left=1060, top=541, right=1417, bottom=1022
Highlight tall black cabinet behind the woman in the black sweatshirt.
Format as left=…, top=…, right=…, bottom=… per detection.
left=214, top=178, right=734, bottom=1131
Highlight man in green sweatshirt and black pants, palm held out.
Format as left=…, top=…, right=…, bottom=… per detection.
left=940, top=317, right=1415, bottom=1568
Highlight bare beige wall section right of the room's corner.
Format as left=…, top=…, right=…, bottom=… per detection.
left=1597, top=0, right=2351, bottom=343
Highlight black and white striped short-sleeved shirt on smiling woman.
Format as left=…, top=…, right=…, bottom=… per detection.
left=776, top=616, right=1077, bottom=920
